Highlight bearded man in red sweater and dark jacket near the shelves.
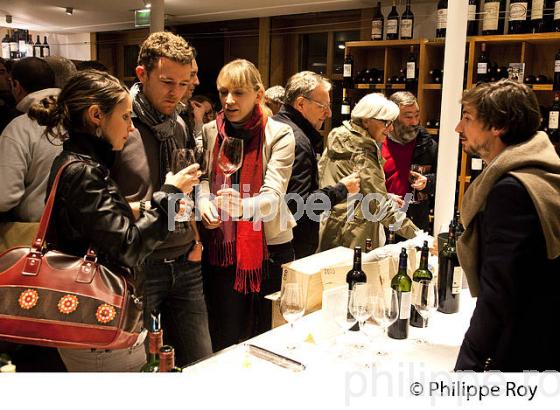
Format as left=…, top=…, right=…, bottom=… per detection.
left=381, top=91, right=437, bottom=231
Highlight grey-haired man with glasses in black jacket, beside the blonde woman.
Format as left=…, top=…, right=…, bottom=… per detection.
left=272, top=71, right=360, bottom=259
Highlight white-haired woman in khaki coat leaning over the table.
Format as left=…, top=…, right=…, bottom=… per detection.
left=319, top=93, right=418, bottom=251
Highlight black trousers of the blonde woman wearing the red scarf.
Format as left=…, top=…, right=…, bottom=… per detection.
left=205, top=242, right=294, bottom=352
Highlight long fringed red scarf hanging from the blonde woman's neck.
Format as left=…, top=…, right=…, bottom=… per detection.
left=208, top=105, right=267, bottom=293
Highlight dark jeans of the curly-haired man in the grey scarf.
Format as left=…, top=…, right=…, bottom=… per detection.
left=143, top=256, right=212, bottom=366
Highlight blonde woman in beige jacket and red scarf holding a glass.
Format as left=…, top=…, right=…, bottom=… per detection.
left=198, top=59, right=295, bottom=351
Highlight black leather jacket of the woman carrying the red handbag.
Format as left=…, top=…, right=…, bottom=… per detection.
left=47, top=133, right=181, bottom=268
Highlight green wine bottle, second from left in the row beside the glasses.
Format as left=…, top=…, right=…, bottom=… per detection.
left=388, top=248, right=412, bottom=339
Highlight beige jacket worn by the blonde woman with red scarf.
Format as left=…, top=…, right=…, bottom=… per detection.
left=199, top=118, right=296, bottom=245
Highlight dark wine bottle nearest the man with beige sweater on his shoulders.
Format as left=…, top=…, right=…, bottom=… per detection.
left=438, top=222, right=463, bottom=313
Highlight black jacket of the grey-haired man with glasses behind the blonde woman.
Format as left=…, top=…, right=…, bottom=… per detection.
left=272, top=105, right=348, bottom=259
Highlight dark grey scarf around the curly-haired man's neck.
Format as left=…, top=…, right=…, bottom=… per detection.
left=130, top=83, right=178, bottom=185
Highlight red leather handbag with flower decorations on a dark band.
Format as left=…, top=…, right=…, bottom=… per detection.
left=0, top=160, right=142, bottom=349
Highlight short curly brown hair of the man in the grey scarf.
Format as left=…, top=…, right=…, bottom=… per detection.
left=138, top=31, right=196, bottom=73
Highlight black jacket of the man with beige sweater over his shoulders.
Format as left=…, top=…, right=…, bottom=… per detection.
left=455, top=176, right=560, bottom=372
